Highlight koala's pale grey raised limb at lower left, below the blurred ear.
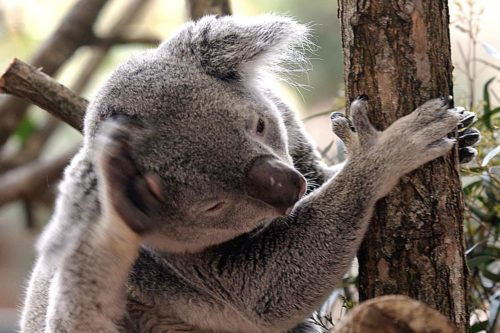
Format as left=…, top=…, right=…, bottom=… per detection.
left=45, top=214, right=139, bottom=332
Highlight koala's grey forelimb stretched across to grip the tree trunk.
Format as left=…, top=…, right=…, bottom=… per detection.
left=160, top=99, right=458, bottom=332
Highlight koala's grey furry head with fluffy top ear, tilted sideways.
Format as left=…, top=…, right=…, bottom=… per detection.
left=85, top=16, right=307, bottom=251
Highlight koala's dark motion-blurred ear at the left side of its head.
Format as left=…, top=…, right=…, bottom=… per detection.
left=95, top=116, right=164, bottom=234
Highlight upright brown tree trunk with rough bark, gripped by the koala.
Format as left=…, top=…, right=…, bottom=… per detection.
left=339, top=0, right=469, bottom=332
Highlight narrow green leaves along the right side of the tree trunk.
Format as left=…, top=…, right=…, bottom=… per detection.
left=462, top=84, right=500, bottom=332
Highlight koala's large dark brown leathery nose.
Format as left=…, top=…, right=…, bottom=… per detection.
left=247, top=156, right=306, bottom=215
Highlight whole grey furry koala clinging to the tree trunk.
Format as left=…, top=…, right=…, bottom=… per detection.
left=21, top=15, right=477, bottom=333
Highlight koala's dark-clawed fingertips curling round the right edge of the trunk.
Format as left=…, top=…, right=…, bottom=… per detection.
left=451, top=106, right=481, bottom=164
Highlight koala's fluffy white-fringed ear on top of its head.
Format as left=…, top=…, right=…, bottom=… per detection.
left=190, top=15, right=311, bottom=79
